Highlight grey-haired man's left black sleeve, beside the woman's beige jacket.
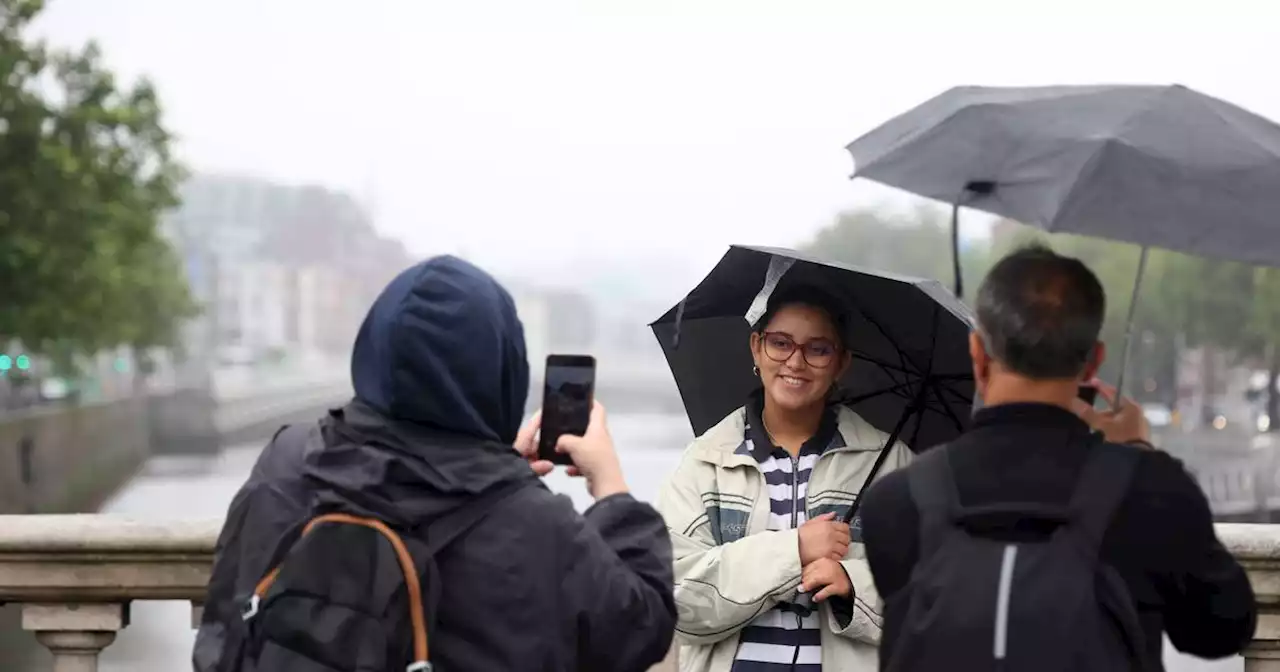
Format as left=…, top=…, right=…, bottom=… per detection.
left=858, top=467, right=919, bottom=604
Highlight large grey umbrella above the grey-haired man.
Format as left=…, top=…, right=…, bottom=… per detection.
left=847, top=86, right=1280, bottom=399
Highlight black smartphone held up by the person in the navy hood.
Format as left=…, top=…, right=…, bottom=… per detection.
left=538, top=355, right=595, bottom=465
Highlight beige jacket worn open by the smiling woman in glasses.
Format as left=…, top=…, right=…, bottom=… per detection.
left=658, top=408, right=911, bottom=672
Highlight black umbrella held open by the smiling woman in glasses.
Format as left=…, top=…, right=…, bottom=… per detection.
left=650, top=246, right=974, bottom=517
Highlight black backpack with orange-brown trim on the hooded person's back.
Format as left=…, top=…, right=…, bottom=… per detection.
left=221, top=465, right=531, bottom=672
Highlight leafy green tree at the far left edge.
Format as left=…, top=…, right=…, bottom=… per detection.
left=0, top=0, right=195, bottom=371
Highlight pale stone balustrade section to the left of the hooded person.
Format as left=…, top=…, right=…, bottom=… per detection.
left=0, top=515, right=675, bottom=672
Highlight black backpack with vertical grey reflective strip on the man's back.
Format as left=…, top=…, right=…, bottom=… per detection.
left=883, top=443, right=1144, bottom=672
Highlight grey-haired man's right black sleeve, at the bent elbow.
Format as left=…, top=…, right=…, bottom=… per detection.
left=1139, top=453, right=1257, bottom=658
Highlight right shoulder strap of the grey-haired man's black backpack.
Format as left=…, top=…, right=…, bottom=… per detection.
left=1068, top=440, right=1138, bottom=556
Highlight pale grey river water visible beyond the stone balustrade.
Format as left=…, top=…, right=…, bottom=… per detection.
left=74, top=415, right=1243, bottom=672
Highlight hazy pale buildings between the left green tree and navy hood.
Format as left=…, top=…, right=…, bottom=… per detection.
left=164, top=175, right=408, bottom=378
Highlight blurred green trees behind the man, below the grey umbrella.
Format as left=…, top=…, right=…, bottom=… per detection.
left=804, top=206, right=1280, bottom=417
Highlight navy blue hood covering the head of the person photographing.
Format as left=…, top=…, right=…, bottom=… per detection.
left=351, top=256, right=529, bottom=445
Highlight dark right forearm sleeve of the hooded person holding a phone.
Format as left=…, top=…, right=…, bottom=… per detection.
left=564, top=494, right=676, bottom=672
